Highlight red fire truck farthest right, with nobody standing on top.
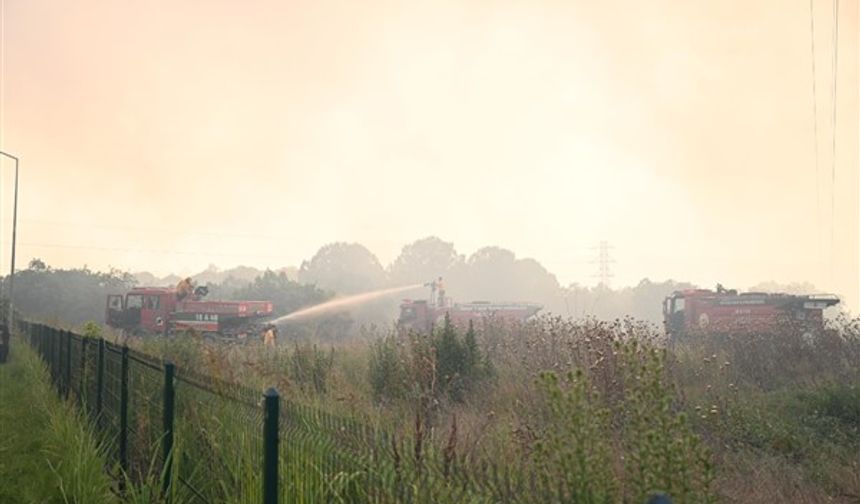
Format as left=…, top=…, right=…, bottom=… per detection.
left=663, top=285, right=839, bottom=337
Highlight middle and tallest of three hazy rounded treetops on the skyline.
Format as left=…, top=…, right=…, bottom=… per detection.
left=388, top=236, right=465, bottom=285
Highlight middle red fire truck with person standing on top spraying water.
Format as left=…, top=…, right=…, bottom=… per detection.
left=397, top=278, right=543, bottom=332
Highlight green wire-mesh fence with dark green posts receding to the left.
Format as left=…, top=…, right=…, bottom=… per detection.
left=18, top=321, right=667, bottom=504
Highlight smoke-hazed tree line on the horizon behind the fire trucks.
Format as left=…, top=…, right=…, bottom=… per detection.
left=2, top=237, right=815, bottom=333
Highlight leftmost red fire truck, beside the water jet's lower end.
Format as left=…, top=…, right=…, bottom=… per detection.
left=105, top=287, right=272, bottom=339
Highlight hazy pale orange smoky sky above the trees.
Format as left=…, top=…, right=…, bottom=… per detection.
left=0, top=0, right=860, bottom=312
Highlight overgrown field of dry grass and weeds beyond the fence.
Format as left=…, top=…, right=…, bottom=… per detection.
left=119, top=317, right=860, bottom=502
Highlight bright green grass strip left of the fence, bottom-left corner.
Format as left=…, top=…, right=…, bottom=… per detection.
left=0, top=338, right=118, bottom=504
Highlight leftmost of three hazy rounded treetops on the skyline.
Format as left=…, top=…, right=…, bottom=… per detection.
left=298, top=242, right=386, bottom=294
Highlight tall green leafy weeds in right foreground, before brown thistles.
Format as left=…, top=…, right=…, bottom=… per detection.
left=533, top=340, right=714, bottom=503
